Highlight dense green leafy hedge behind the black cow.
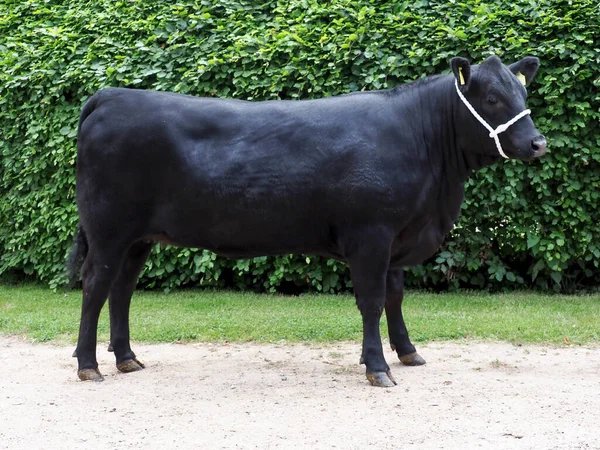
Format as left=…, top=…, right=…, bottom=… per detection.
left=0, top=0, right=600, bottom=292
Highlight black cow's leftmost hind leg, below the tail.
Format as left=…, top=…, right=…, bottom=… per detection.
left=74, top=246, right=123, bottom=381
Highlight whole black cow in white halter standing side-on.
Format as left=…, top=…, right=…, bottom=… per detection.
left=71, top=56, right=546, bottom=386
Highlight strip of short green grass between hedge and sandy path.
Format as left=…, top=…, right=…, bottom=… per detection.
left=0, top=285, right=600, bottom=345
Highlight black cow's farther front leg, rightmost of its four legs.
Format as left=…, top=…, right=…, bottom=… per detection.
left=385, top=268, right=425, bottom=366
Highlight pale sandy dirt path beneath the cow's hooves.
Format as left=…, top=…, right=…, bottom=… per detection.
left=0, top=337, right=600, bottom=450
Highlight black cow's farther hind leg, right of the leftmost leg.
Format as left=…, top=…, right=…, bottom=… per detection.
left=108, top=241, right=152, bottom=372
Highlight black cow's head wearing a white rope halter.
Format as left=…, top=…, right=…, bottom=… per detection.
left=450, top=56, right=546, bottom=160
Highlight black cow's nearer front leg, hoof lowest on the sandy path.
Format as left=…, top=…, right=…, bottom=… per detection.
left=348, top=229, right=396, bottom=387
